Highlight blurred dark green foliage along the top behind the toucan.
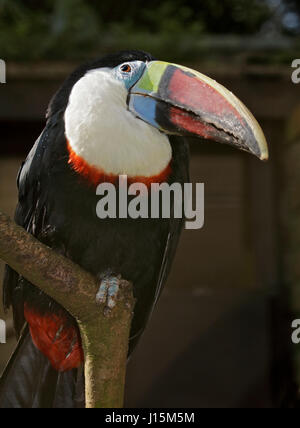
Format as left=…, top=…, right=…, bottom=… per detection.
left=0, top=0, right=296, bottom=60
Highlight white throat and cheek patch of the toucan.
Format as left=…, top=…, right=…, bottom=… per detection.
left=65, top=69, right=172, bottom=177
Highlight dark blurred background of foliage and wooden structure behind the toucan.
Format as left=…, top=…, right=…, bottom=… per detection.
left=0, top=0, right=300, bottom=408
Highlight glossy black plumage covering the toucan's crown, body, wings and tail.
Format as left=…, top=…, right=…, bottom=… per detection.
left=0, top=51, right=189, bottom=407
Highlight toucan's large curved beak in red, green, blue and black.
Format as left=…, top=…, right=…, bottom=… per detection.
left=128, top=61, right=268, bottom=160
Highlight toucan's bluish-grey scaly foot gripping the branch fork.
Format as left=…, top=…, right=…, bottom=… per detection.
left=96, top=275, right=122, bottom=315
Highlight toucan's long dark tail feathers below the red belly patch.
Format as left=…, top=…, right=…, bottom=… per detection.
left=0, top=327, right=84, bottom=408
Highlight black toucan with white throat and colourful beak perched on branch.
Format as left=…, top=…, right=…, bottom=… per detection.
left=0, top=51, right=268, bottom=408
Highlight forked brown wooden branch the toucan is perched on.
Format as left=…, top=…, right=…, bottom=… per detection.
left=0, top=212, right=135, bottom=408
